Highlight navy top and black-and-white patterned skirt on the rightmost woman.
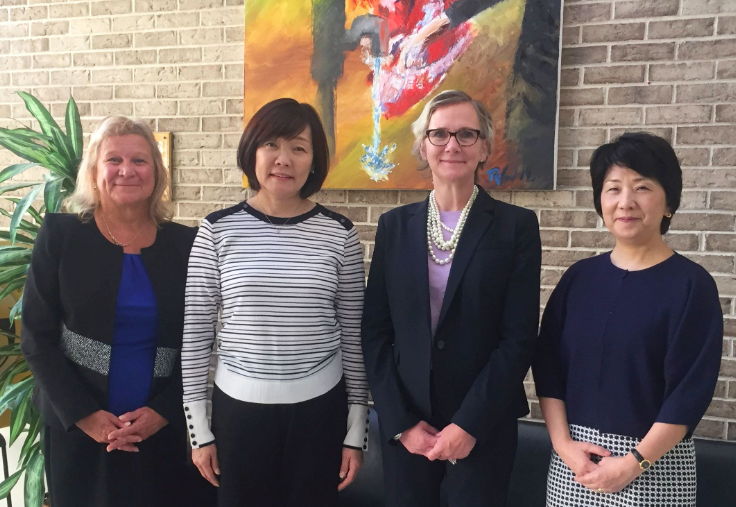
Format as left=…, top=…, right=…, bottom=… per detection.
left=532, top=253, right=723, bottom=507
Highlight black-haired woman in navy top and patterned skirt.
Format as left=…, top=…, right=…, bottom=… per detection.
left=533, top=133, right=723, bottom=507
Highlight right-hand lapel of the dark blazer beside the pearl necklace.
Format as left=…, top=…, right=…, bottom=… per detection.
left=436, top=189, right=495, bottom=329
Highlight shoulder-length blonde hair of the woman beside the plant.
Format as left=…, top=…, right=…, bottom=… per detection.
left=67, top=116, right=173, bottom=225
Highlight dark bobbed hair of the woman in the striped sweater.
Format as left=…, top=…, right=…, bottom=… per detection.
left=238, top=98, right=330, bottom=199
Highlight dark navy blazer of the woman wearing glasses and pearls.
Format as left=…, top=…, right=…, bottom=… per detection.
left=362, top=190, right=542, bottom=443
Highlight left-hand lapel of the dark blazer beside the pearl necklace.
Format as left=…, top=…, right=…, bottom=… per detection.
left=407, top=199, right=432, bottom=338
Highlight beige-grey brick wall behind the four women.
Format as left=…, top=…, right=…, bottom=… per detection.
left=0, top=0, right=736, bottom=440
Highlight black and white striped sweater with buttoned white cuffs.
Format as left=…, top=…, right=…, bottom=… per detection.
left=182, top=202, right=368, bottom=449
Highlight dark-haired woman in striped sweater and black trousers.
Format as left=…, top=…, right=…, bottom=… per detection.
left=182, top=99, right=368, bottom=507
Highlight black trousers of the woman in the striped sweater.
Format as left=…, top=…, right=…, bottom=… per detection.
left=212, top=380, right=348, bottom=507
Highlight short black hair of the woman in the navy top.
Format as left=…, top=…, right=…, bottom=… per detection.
left=590, top=132, right=682, bottom=234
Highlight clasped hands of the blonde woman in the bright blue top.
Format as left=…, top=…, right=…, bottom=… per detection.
left=77, top=407, right=168, bottom=452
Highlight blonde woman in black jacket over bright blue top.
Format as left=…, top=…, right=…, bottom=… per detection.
left=21, top=117, right=210, bottom=507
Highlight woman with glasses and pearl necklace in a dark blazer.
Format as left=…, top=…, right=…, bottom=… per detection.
left=362, top=91, right=541, bottom=507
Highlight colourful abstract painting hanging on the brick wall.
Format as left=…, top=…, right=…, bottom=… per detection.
left=244, top=0, right=561, bottom=190
